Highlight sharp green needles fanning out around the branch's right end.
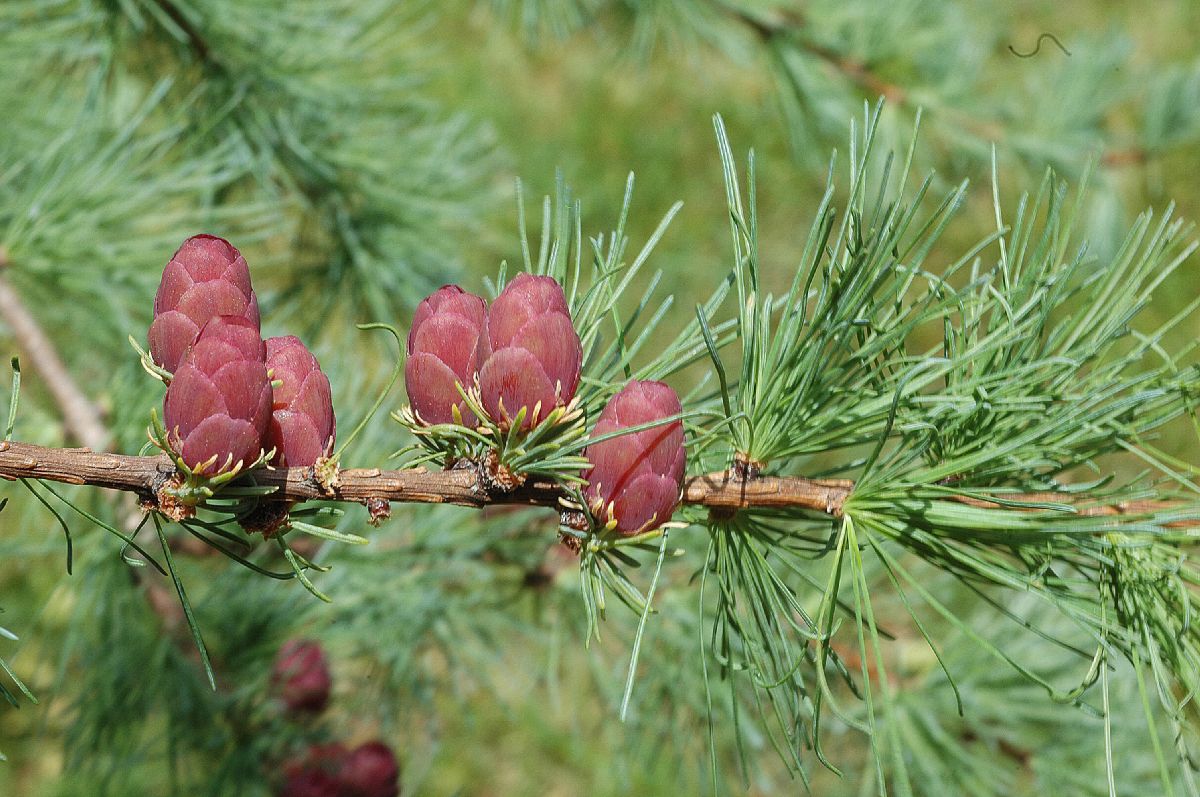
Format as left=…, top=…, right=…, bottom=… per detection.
left=691, top=112, right=1200, bottom=793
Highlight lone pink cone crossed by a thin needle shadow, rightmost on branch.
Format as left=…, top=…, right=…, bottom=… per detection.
left=583, top=379, right=686, bottom=534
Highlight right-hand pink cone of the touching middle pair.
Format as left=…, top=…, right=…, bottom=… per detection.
left=479, top=274, right=583, bottom=429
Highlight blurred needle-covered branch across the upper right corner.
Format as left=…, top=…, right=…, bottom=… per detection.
left=492, top=0, right=1200, bottom=258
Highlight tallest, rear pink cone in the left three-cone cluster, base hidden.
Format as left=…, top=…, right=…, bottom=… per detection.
left=149, top=235, right=258, bottom=373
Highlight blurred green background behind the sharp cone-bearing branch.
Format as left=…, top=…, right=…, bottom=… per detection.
left=0, top=0, right=1200, bottom=796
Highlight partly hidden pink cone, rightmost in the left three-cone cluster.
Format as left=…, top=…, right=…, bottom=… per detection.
left=263, top=335, right=335, bottom=468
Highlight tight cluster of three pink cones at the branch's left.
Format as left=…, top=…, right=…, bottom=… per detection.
left=149, top=235, right=335, bottom=475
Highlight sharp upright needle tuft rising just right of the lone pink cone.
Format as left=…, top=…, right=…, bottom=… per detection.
left=718, top=112, right=974, bottom=466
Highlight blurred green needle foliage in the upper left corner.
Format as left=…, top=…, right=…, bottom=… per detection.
left=7, top=0, right=490, bottom=338
